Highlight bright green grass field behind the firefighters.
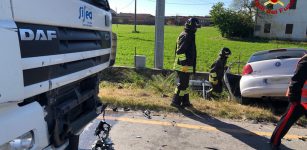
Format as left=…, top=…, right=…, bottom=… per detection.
left=113, top=25, right=307, bottom=71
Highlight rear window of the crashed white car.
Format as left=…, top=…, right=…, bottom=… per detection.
left=248, top=50, right=307, bottom=63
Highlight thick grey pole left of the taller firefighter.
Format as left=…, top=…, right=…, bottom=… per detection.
left=155, top=0, right=165, bottom=69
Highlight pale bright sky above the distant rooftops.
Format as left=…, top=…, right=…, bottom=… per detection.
left=109, top=0, right=232, bottom=16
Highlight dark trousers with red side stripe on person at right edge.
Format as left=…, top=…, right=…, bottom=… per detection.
left=270, top=103, right=307, bottom=146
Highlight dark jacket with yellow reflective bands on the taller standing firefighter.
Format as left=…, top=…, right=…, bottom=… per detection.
left=174, top=30, right=197, bottom=73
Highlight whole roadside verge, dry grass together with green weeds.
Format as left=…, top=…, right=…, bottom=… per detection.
left=99, top=68, right=307, bottom=126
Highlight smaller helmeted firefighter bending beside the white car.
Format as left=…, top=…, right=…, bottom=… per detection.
left=209, top=47, right=231, bottom=94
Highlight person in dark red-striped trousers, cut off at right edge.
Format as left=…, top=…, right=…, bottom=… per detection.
left=270, top=54, right=307, bottom=149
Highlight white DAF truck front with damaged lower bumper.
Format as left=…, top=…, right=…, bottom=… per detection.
left=0, top=0, right=116, bottom=150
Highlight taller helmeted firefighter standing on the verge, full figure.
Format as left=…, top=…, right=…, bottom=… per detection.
left=171, top=18, right=201, bottom=108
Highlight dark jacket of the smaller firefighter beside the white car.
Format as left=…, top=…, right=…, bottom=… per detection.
left=209, top=56, right=227, bottom=85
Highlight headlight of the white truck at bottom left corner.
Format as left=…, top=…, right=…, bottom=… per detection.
left=0, top=131, right=34, bottom=150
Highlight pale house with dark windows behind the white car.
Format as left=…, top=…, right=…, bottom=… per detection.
left=254, top=0, right=307, bottom=41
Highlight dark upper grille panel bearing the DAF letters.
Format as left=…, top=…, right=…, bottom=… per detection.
left=16, top=23, right=111, bottom=58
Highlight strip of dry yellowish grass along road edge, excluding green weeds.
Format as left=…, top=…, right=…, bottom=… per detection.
left=99, top=86, right=278, bottom=122
